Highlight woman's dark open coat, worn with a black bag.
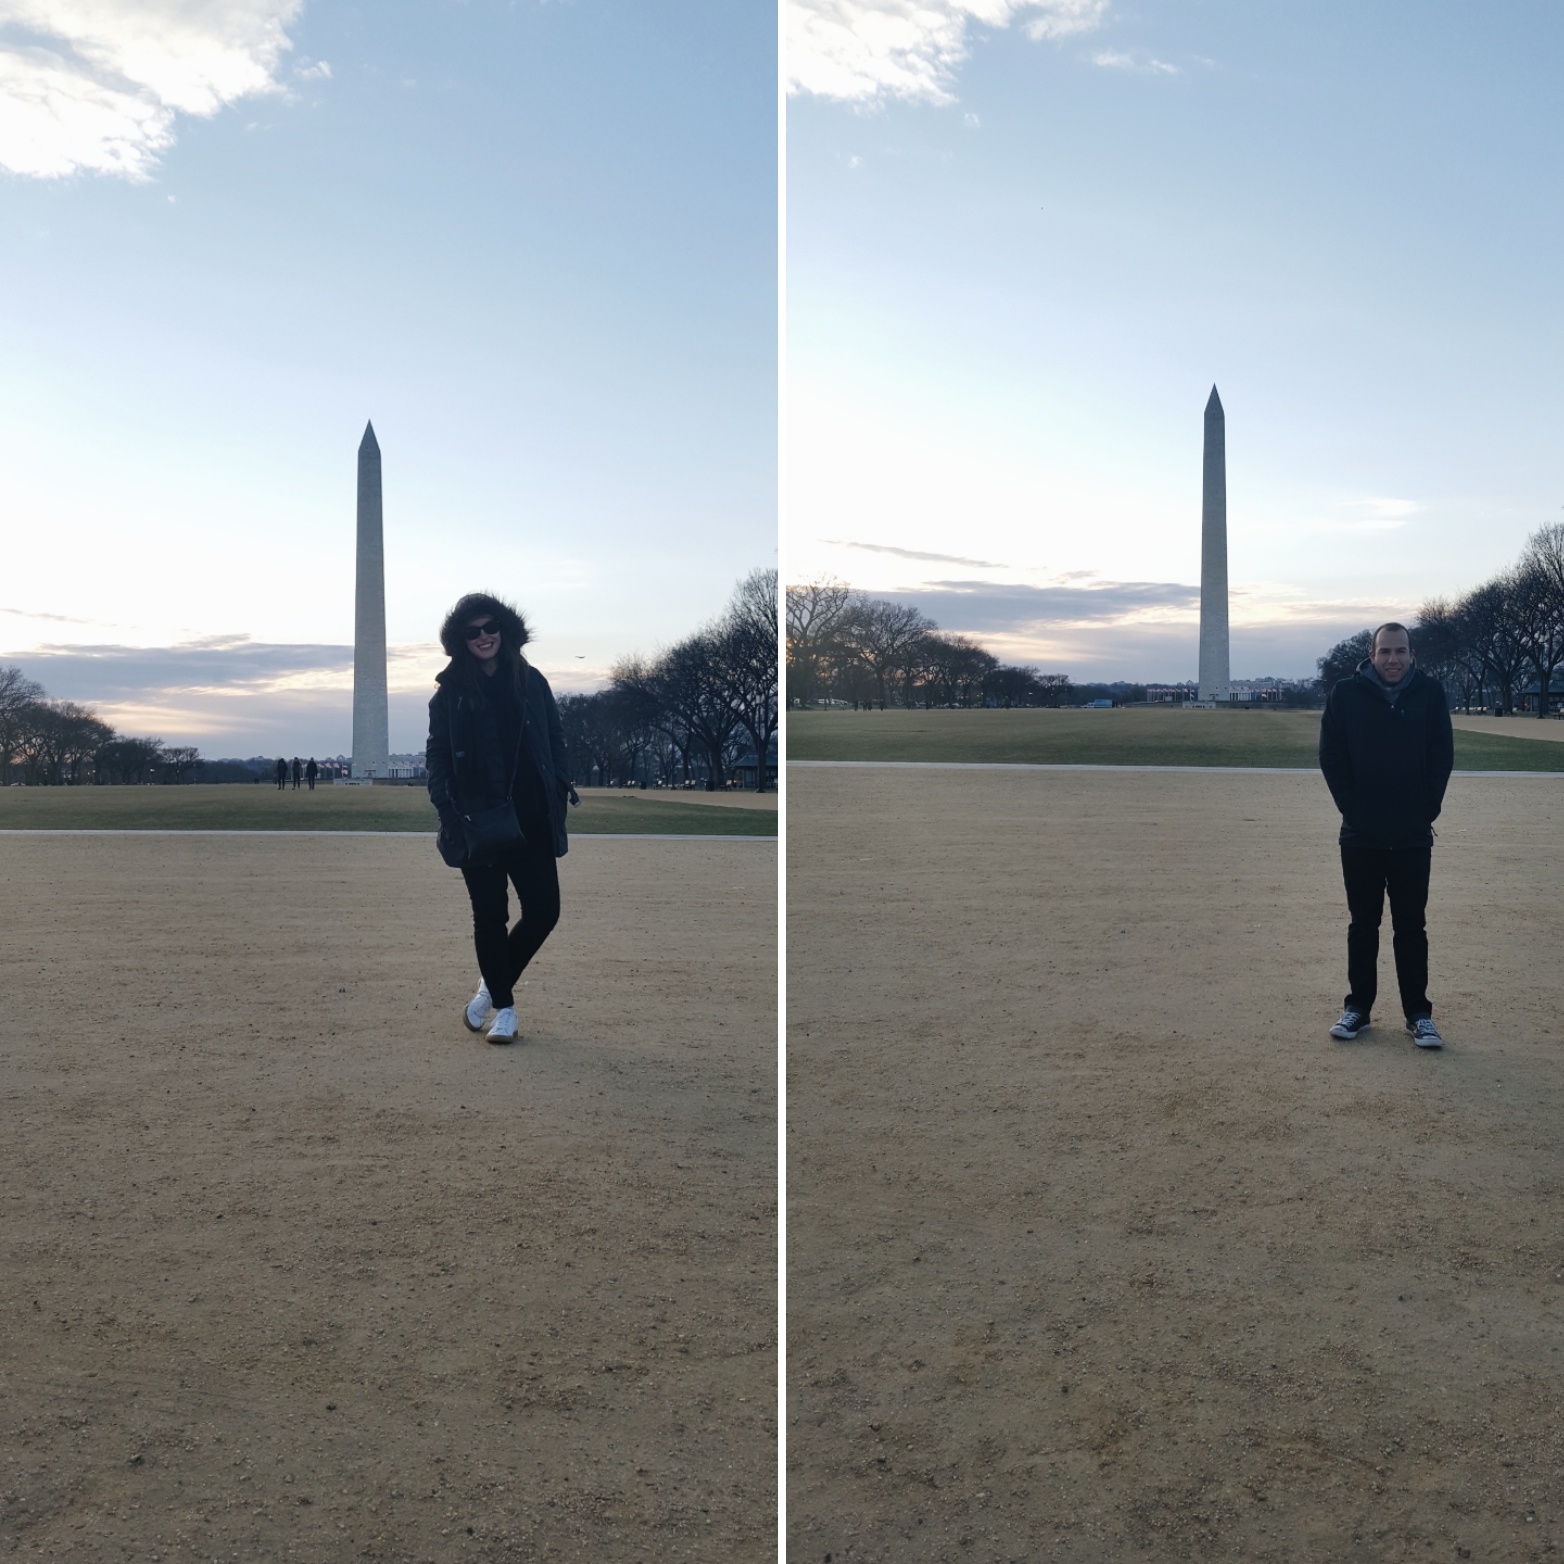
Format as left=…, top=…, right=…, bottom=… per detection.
left=424, top=663, right=571, bottom=859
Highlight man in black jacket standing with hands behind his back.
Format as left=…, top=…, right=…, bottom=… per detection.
left=1320, top=624, right=1455, bottom=1048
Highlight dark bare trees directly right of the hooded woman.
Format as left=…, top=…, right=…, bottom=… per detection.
left=560, top=569, right=777, bottom=791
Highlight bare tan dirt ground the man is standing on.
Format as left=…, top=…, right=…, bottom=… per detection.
left=788, top=769, right=1564, bottom=1564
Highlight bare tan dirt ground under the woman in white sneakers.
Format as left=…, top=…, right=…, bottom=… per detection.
left=0, top=835, right=776, bottom=1564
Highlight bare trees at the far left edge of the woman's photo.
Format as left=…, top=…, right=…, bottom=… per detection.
left=0, top=666, right=200, bottom=787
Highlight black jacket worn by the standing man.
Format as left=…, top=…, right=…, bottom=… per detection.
left=1320, top=663, right=1455, bottom=848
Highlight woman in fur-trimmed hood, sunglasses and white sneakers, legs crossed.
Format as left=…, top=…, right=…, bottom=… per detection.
left=425, top=593, right=580, bottom=1043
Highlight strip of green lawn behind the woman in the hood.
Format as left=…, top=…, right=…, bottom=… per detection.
left=0, top=782, right=777, bottom=837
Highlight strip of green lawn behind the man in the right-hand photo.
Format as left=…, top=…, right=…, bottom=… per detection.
left=787, top=707, right=1564, bottom=771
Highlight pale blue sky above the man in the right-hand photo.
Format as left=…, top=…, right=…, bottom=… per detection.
left=788, top=0, right=1564, bottom=679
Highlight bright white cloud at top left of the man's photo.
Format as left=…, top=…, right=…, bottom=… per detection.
left=787, top=0, right=1107, bottom=103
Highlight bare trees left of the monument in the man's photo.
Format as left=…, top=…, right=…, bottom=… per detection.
left=787, top=577, right=1070, bottom=710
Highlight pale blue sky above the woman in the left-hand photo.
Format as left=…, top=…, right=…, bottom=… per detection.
left=0, top=0, right=777, bottom=754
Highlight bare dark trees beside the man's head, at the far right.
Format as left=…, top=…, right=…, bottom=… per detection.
left=1320, top=522, right=1564, bottom=716
